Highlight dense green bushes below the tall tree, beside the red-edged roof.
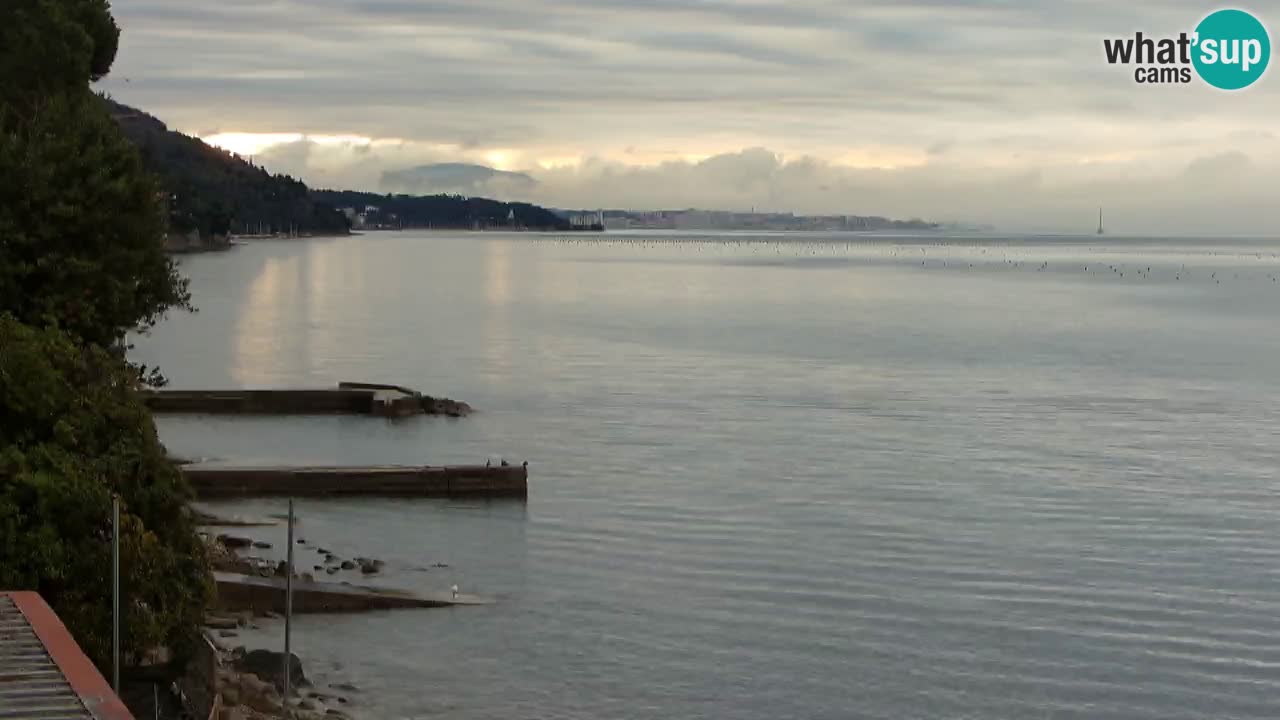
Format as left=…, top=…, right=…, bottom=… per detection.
left=0, top=315, right=210, bottom=667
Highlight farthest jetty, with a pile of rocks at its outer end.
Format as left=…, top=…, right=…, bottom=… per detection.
left=142, top=382, right=471, bottom=418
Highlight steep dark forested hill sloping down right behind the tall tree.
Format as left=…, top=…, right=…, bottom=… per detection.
left=105, top=100, right=349, bottom=237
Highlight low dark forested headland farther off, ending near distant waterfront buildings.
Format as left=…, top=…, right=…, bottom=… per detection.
left=311, top=190, right=570, bottom=231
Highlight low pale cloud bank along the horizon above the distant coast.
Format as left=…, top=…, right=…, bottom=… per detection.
left=238, top=135, right=1280, bottom=234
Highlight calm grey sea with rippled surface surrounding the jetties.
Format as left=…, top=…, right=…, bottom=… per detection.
left=136, top=233, right=1280, bottom=720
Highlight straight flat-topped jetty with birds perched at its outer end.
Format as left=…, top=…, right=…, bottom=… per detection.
left=182, top=465, right=529, bottom=500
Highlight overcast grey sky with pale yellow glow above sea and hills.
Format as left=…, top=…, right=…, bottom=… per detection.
left=100, top=0, right=1280, bottom=234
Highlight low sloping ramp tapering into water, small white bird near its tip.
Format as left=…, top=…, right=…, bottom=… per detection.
left=214, top=573, right=484, bottom=614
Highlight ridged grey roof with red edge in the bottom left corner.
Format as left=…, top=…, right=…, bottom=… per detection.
left=0, top=592, right=133, bottom=720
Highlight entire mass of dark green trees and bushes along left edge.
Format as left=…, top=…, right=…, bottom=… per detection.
left=0, top=0, right=210, bottom=667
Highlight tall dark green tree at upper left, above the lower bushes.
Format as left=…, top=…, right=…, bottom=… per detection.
left=0, top=0, right=189, bottom=345
